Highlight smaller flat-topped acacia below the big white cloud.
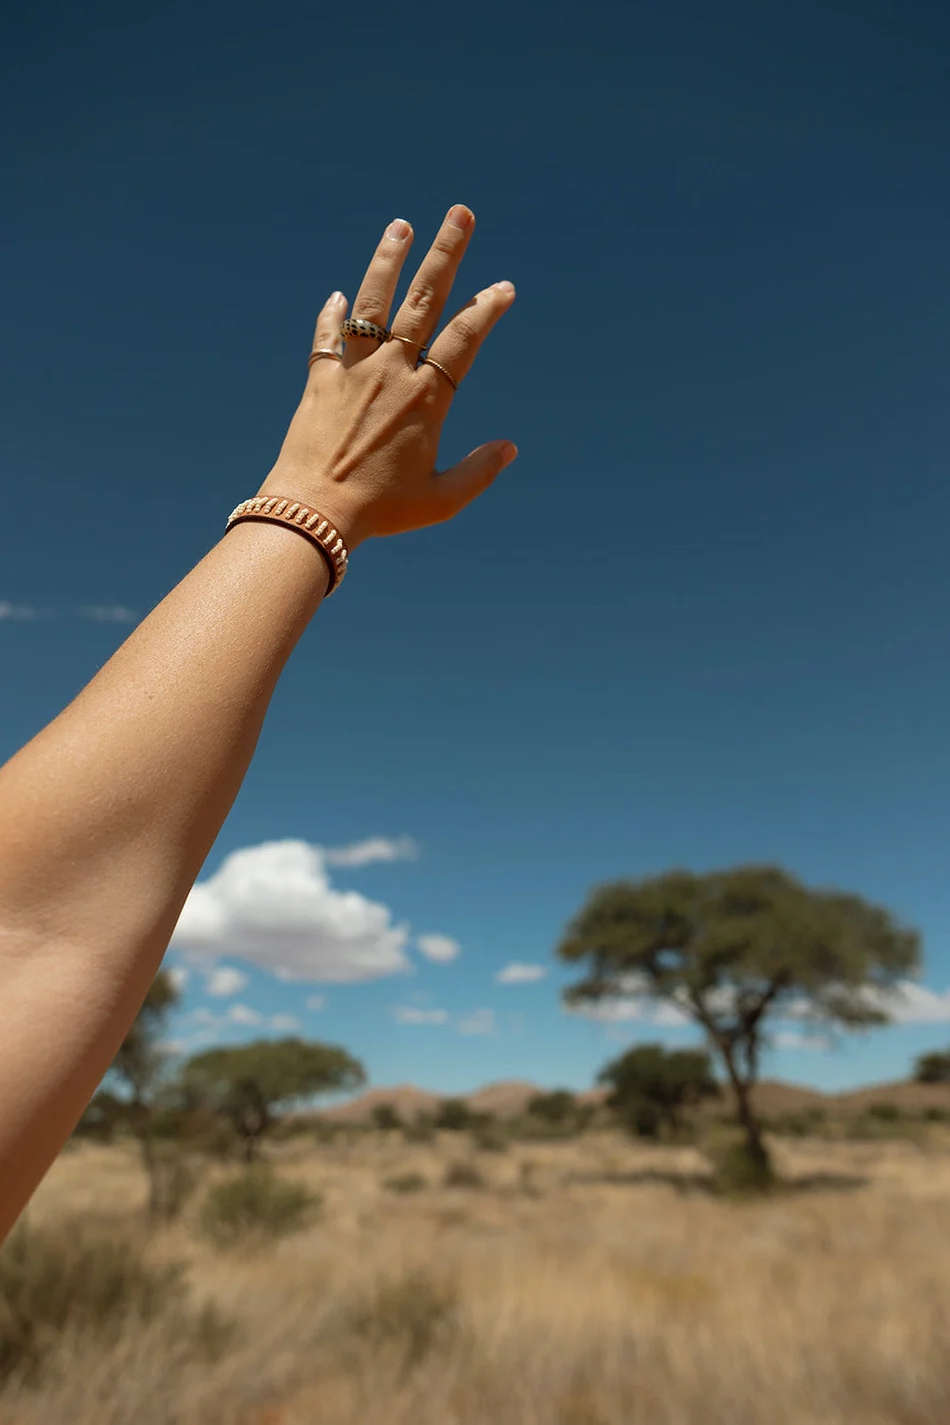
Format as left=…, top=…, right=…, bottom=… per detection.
left=181, top=1039, right=366, bottom=1163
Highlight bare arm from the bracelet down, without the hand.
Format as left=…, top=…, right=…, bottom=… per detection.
left=0, top=523, right=328, bottom=1238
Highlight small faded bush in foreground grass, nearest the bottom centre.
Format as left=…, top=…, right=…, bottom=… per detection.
left=345, top=1271, right=459, bottom=1367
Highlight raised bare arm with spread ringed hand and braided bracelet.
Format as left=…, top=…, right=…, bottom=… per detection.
left=0, top=207, right=516, bottom=1240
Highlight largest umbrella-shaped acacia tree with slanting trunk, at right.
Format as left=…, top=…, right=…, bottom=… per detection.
left=557, top=865, right=920, bottom=1166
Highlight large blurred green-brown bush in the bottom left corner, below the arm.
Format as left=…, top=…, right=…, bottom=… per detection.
left=0, top=1220, right=235, bottom=1381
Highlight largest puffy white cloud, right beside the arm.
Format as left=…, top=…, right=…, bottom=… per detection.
left=172, top=841, right=410, bottom=982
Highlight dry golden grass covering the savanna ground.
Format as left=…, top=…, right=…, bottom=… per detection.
left=0, top=1129, right=950, bottom=1425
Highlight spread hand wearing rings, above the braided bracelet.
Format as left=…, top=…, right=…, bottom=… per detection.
left=258, top=204, right=517, bottom=551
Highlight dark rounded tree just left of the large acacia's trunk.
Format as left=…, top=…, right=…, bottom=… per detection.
left=597, top=1045, right=721, bottom=1137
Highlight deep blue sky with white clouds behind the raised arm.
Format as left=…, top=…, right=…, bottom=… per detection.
left=0, top=0, right=950, bottom=1092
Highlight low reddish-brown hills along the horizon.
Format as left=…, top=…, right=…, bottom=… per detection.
left=303, top=1079, right=950, bottom=1123
